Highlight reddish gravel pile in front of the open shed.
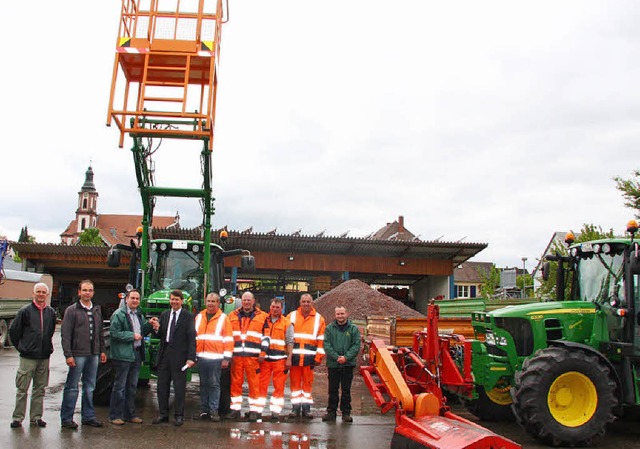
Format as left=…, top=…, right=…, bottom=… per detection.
left=313, top=279, right=424, bottom=324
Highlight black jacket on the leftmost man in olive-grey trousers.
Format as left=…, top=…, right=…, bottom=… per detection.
left=9, top=302, right=56, bottom=359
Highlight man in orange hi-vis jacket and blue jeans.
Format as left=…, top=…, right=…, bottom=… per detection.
left=195, top=293, right=233, bottom=422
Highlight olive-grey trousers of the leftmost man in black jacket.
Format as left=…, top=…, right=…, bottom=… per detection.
left=13, top=357, right=49, bottom=422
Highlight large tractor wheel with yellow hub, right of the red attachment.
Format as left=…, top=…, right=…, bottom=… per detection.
left=513, top=347, right=618, bottom=447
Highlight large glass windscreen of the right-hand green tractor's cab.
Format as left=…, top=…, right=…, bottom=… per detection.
left=576, top=251, right=624, bottom=304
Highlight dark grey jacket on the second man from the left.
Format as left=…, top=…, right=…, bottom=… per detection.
left=60, top=300, right=105, bottom=358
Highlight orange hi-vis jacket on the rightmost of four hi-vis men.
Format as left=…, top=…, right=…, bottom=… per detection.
left=289, top=307, right=325, bottom=366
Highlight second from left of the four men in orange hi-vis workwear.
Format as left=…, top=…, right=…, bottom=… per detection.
left=227, top=292, right=268, bottom=421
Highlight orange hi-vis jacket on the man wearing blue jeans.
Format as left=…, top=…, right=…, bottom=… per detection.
left=196, top=309, right=233, bottom=360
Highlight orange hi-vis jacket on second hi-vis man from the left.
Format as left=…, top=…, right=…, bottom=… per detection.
left=229, top=309, right=268, bottom=357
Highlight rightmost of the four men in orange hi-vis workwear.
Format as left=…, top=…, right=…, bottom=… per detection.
left=288, top=293, right=325, bottom=420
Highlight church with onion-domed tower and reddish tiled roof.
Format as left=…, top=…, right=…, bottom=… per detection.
left=60, top=166, right=180, bottom=246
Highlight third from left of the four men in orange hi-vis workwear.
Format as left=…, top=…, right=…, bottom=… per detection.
left=260, top=298, right=293, bottom=422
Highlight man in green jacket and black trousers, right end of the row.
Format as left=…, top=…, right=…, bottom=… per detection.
left=322, top=307, right=360, bottom=422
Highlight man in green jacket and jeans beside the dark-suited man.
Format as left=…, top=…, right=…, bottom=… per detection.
left=109, top=290, right=160, bottom=426
